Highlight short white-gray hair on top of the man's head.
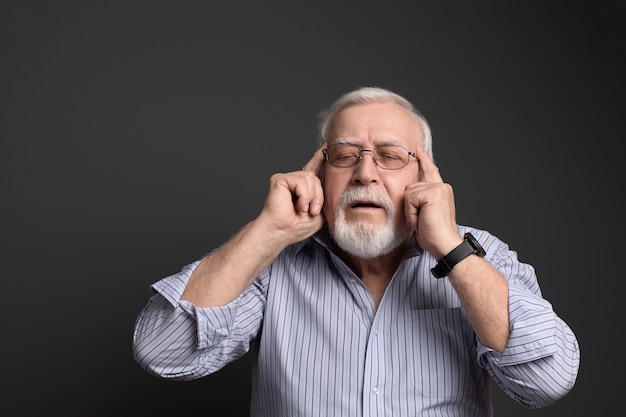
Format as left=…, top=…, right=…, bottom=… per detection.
left=317, top=87, right=433, bottom=159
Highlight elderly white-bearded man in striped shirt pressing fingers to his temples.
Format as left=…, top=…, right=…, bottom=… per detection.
left=133, top=87, right=580, bottom=417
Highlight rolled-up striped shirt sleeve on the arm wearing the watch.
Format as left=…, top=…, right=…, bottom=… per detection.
left=478, top=236, right=580, bottom=409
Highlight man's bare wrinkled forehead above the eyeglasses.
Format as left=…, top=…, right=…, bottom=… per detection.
left=326, top=102, right=423, bottom=147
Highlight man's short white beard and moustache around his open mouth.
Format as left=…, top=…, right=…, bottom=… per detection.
left=330, top=187, right=410, bottom=259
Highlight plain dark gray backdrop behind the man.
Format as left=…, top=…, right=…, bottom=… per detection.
left=0, top=0, right=626, bottom=416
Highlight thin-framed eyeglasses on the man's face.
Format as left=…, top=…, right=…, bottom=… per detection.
left=322, top=143, right=417, bottom=169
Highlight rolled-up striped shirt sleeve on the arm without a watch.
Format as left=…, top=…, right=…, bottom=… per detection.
left=133, top=261, right=267, bottom=380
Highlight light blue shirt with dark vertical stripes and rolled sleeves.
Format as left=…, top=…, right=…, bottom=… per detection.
left=133, top=226, right=580, bottom=417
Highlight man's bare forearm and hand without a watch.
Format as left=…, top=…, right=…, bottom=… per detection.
left=181, top=148, right=324, bottom=307
